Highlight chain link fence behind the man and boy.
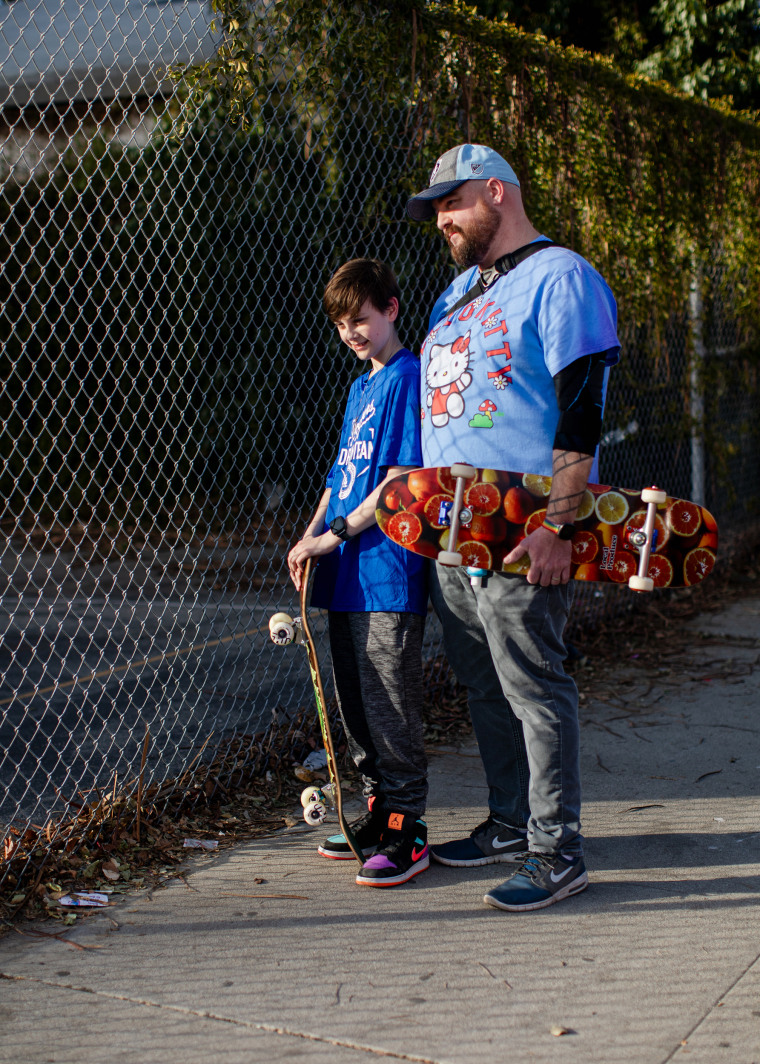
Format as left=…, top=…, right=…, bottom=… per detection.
left=0, top=0, right=760, bottom=880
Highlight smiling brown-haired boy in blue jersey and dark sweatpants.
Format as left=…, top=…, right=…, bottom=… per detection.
left=287, top=259, right=429, bottom=886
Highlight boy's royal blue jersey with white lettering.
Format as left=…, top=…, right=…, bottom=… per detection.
left=312, top=349, right=428, bottom=615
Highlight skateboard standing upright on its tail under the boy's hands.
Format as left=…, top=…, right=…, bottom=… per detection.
left=269, top=558, right=364, bottom=865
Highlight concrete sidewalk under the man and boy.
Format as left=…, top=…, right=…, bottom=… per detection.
left=0, top=599, right=760, bottom=1064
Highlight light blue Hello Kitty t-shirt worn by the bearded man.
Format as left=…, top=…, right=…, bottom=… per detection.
left=420, top=237, right=619, bottom=480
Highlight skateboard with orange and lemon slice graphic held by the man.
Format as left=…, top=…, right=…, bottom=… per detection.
left=376, top=463, right=717, bottom=592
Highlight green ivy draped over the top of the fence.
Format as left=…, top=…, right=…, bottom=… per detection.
left=180, top=0, right=760, bottom=355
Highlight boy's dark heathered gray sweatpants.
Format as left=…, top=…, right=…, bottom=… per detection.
left=328, top=610, right=428, bottom=816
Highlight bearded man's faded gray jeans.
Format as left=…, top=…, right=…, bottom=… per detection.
left=430, top=563, right=582, bottom=854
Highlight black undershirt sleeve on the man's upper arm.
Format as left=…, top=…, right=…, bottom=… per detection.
left=554, top=351, right=607, bottom=454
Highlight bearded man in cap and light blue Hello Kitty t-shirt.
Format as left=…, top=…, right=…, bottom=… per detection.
left=408, top=144, right=619, bottom=912
